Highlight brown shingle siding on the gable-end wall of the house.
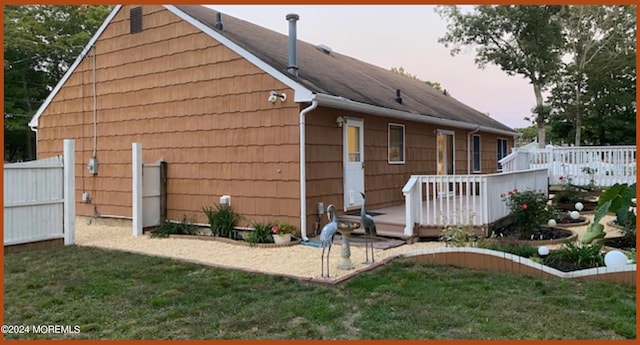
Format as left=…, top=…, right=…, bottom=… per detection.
left=38, top=6, right=299, bottom=226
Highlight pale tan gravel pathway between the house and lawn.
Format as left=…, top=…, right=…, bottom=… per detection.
left=76, top=215, right=619, bottom=281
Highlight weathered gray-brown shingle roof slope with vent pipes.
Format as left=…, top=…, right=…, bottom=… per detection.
left=176, top=5, right=515, bottom=133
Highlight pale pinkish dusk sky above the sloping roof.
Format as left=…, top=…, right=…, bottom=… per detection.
left=210, top=5, right=535, bottom=128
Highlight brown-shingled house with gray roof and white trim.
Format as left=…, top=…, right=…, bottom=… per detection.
left=30, top=5, right=517, bottom=237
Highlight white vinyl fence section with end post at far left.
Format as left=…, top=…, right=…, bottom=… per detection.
left=4, top=140, right=75, bottom=246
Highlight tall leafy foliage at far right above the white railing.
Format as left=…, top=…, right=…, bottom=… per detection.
left=550, top=5, right=636, bottom=146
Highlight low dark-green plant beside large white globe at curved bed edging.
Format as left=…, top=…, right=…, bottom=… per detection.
left=544, top=241, right=604, bottom=270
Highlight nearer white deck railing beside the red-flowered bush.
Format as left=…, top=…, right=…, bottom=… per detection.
left=402, top=169, right=548, bottom=236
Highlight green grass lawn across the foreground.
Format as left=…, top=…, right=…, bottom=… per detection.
left=4, top=246, right=636, bottom=339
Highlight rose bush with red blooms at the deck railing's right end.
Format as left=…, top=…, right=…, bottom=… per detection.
left=500, top=189, right=554, bottom=237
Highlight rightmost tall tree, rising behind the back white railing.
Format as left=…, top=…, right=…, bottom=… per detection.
left=550, top=5, right=636, bottom=146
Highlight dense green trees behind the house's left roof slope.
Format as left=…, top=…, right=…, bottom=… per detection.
left=4, top=5, right=112, bottom=161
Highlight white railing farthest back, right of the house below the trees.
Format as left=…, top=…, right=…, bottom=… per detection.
left=500, top=146, right=636, bottom=186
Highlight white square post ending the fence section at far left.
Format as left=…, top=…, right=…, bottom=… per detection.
left=62, top=139, right=76, bottom=246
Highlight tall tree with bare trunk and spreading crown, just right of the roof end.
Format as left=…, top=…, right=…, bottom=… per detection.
left=436, top=5, right=564, bottom=147
